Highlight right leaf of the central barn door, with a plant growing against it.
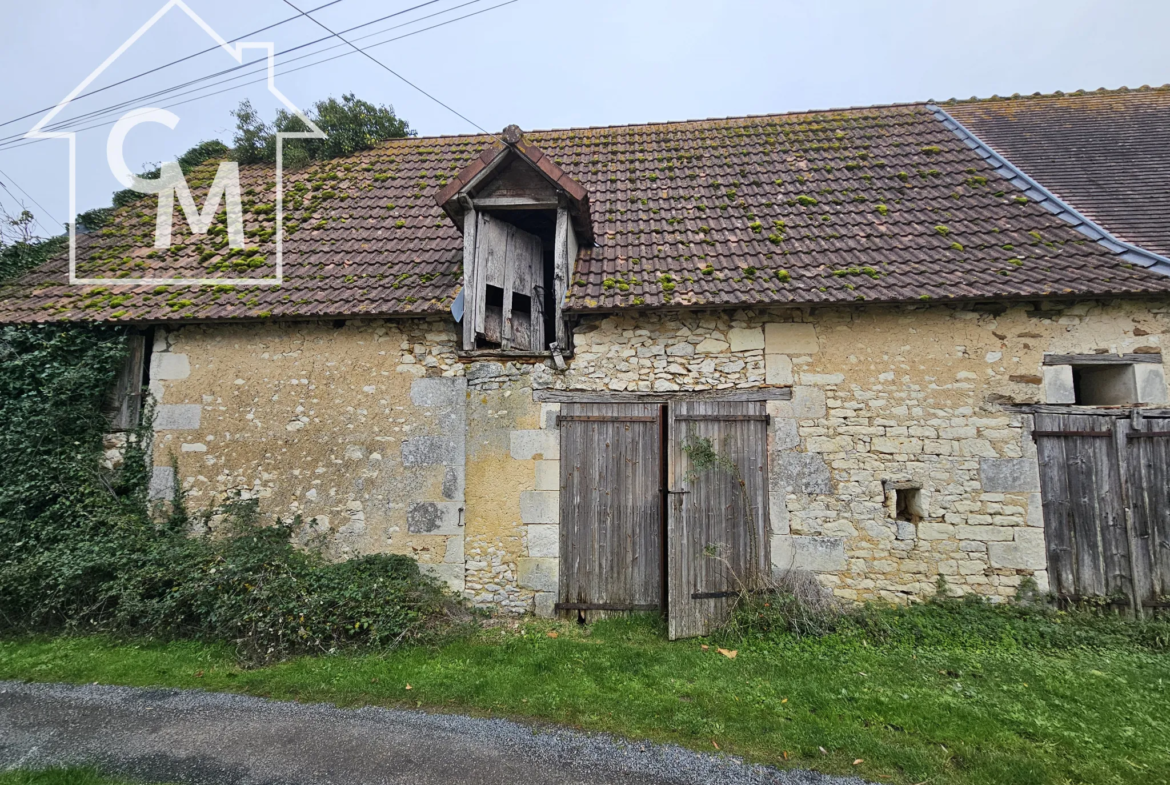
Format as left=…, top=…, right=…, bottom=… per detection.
left=667, top=401, right=769, bottom=640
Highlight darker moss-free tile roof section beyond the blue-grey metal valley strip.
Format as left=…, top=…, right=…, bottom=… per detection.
left=943, top=87, right=1170, bottom=256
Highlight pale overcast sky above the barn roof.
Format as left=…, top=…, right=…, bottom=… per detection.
left=0, top=0, right=1170, bottom=230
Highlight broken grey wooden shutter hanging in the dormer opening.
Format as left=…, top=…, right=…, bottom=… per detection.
left=463, top=211, right=545, bottom=351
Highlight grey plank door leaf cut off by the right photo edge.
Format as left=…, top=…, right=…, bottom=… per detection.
left=1117, top=418, right=1170, bottom=604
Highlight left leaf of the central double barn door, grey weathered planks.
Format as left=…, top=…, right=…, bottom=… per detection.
left=558, top=404, right=662, bottom=621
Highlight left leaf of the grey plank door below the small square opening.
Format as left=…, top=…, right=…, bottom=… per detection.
left=1034, top=414, right=1133, bottom=600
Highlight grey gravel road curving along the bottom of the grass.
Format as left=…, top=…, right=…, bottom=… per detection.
left=0, top=682, right=865, bottom=785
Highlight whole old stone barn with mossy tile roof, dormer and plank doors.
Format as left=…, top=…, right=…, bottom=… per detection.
left=0, top=89, right=1170, bottom=636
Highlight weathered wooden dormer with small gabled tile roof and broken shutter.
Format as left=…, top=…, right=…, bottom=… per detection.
left=436, top=125, right=593, bottom=354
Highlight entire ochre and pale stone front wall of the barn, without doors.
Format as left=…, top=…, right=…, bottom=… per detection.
left=151, top=302, right=1170, bottom=613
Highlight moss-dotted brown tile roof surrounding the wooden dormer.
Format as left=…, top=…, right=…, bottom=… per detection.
left=0, top=98, right=1170, bottom=322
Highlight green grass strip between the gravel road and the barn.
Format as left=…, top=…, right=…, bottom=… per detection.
left=0, top=619, right=1170, bottom=785
